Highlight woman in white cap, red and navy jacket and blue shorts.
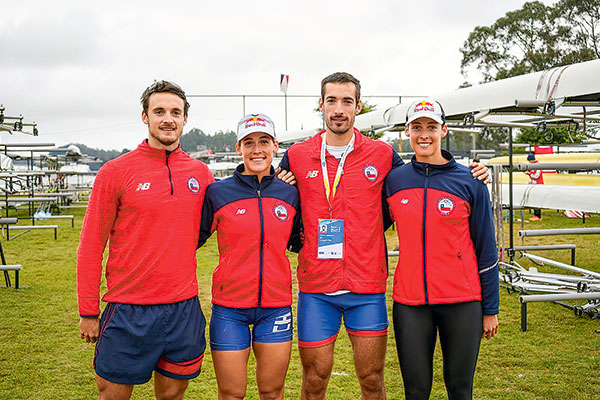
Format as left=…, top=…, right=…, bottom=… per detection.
left=199, top=114, right=300, bottom=399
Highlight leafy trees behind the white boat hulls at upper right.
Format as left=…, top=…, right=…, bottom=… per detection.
left=455, top=0, right=600, bottom=150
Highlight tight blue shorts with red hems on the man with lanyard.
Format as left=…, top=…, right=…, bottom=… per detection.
left=298, top=292, right=389, bottom=347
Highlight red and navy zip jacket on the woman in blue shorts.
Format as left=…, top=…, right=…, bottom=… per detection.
left=198, top=164, right=300, bottom=308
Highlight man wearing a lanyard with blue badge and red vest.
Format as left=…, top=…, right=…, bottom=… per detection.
left=281, top=73, right=402, bottom=399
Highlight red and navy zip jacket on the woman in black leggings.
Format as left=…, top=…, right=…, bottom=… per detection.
left=385, top=150, right=499, bottom=314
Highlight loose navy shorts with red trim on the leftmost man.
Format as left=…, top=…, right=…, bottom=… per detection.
left=94, top=297, right=206, bottom=385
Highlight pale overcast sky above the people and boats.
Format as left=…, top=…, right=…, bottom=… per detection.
left=0, top=0, right=552, bottom=150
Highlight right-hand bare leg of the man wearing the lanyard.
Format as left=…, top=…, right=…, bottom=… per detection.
left=349, top=335, right=387, bottom=400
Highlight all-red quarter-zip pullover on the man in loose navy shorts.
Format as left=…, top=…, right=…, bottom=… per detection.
left=77, top=141, right=214, bottom=317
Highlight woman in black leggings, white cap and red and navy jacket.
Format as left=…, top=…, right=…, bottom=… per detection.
left=385, top=99, right=499, bottom=400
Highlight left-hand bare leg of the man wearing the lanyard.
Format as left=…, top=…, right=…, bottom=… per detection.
left=300, top=342, right=335, bottom=400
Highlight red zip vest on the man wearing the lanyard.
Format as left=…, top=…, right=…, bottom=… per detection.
left=280, top=130, right=402, bottom=293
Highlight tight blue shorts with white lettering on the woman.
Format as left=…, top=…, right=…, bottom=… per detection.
left=210, top=304, right=293, bottom=351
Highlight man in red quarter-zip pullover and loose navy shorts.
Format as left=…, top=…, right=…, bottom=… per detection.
left=77, top=81, right=214, bottom=399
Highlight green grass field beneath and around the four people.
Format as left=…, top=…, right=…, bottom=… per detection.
left=0, top=211, right=600, bottom=400
